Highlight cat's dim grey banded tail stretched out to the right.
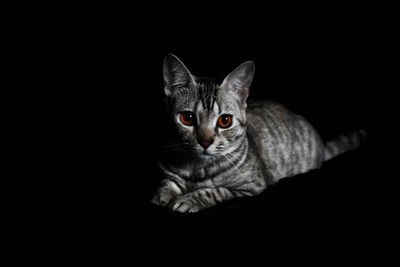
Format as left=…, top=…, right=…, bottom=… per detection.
left=324, top=130, right=367, bottom=161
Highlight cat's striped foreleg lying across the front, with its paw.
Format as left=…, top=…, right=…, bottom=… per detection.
left=168, top=187, right=236, bottom=212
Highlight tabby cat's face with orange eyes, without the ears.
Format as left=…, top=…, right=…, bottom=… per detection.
left=166, top=79, right=246, bottom=158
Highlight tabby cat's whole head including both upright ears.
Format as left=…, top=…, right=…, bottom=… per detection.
left=163, top=54, right=255, bottom=158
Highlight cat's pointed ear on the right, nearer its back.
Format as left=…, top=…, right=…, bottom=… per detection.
left=221, top=61, right=255, bottom=102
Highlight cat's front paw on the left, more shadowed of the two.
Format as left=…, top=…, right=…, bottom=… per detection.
left=151, top=179, right=185, bottom=206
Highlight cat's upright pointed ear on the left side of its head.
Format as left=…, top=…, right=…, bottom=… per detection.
left=163, top=54, right=195, bottom=96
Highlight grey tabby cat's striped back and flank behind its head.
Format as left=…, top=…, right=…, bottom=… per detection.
left=246, top=101, right=323, bottom=181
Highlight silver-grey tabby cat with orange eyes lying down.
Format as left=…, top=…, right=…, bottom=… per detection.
left=151, top=54, right=365, bottom=213
